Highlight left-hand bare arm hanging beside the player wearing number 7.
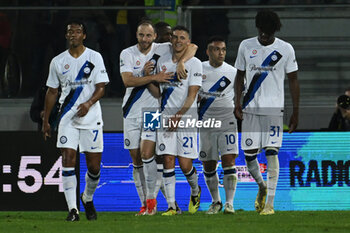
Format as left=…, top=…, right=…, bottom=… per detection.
left=42, top=87, right=58, bottom=140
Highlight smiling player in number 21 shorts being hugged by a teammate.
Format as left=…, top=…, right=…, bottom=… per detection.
left=149, top=26, right=202, bottom=216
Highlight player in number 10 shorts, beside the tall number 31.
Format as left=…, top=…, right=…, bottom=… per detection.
left=198, top=36, right=238, bottom=214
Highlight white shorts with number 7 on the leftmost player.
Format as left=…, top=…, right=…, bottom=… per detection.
left=57, top=126, right=103, bottom=153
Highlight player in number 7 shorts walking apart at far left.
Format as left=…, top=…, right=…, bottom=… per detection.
left=42, top=21, right=108, bottom=221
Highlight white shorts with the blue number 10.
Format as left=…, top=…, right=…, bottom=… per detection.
left=199, top=118, right=238, bottom=161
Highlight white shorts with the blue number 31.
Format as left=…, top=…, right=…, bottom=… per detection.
left=241, top=113, right=283, bottom=150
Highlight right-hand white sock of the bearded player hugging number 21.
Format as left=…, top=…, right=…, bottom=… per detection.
left=142, top=156, right=157, bottom=199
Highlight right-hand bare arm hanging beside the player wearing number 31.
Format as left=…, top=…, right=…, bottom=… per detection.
left=287, top=71, right=300, bottom=133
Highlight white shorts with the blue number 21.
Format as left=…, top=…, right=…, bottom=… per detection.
left=156, top=129, right=198, bottom=159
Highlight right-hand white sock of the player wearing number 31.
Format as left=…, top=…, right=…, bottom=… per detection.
left=266, top=155, right=280, bottom=206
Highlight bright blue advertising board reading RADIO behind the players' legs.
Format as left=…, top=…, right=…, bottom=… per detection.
left=80, top=132, right=350, bottom=211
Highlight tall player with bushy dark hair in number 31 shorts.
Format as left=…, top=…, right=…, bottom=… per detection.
left=235, top=10, right=300, bottom=215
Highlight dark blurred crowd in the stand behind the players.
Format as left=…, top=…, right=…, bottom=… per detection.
left=0, top=0, right=348, bottom=98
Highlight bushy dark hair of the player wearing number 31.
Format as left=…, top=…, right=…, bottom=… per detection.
left=255, top=10, right=282, bottom=34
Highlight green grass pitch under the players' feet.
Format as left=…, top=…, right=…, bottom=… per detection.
left=0, top=211, right=350, bottom=233
